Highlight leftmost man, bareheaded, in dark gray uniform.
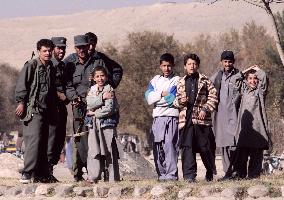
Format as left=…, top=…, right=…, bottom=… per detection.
left=15, top=39, right=58, bottom=183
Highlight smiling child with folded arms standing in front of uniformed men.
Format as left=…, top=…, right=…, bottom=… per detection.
left=86, top=66, right=120, bottom=183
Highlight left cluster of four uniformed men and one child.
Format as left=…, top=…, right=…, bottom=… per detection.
left=15, top=32, right=123, bottom=183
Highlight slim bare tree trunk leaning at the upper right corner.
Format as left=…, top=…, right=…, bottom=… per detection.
left=262, top=0, right=284, bottom=66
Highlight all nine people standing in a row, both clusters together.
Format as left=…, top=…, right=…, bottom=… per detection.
left=15, top=32, right=269, bottom=183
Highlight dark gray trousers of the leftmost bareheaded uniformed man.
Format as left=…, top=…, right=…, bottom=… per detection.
left=23, top=113, right=56, bottom=177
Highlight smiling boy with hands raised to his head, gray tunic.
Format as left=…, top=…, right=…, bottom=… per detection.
left=234, top=66, right=270, bottom=178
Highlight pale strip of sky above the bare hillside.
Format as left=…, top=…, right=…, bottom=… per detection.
left=0, top=0, right=191, bottom=19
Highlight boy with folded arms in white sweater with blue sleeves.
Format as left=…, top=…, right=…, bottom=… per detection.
left=145, top=53, right=179, bottom=181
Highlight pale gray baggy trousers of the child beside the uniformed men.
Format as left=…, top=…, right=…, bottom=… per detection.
left=87, top=129, right=120, bottom=181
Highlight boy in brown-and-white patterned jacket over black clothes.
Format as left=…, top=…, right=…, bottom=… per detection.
left=174, top=54, right=218, bottom=183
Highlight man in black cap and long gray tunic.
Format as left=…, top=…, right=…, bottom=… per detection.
left=211, top=50, right=239, bottom=180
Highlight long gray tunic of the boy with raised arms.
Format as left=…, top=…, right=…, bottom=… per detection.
left=234, top=70, right=270, bottom=149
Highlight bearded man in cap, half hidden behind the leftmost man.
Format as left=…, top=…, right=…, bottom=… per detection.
left=47, top=37, right=69, bottom=174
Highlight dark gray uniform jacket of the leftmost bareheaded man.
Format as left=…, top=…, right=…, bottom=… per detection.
left=15, top=58, right=58, bottom=121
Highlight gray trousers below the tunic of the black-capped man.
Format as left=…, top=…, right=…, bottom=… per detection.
left=221, top=146, right=236, bottom=175
